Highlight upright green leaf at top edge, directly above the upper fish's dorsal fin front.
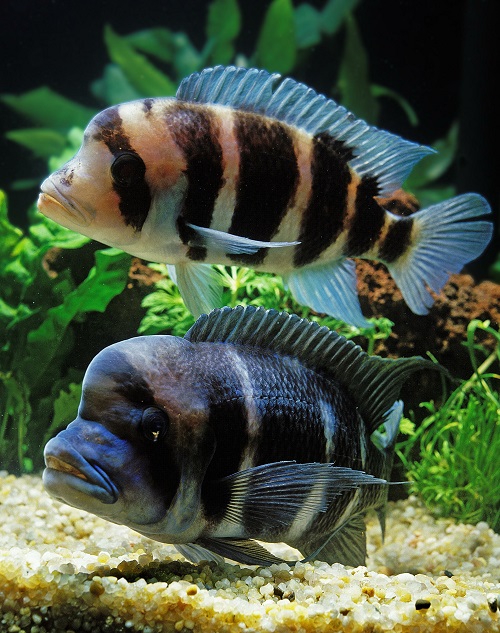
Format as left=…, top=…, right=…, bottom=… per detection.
left=255, top=0, right=297, bottom=74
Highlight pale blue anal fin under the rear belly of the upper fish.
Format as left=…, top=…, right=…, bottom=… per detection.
left=283, top=259, right=371, bottom=327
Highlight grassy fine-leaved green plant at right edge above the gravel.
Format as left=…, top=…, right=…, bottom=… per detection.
left=397, top=320, right=500, bottom=532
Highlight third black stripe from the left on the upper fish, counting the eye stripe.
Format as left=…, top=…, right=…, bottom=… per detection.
left=229, top=112, right=299, bottom=265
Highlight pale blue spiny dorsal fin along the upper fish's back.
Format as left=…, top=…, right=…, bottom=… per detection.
left=176, top=66, right=434, bottom=196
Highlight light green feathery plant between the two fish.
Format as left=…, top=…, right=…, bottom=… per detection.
left=138, top=264, right=394, bottom=354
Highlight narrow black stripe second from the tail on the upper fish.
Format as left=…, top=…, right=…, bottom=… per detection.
left=344, top=176, right=385, bottom=257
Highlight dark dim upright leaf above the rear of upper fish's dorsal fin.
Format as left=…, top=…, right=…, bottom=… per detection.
left=338, top=15, right=379, bottom=124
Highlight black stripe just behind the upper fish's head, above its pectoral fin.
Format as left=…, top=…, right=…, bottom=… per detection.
left=166, top=102, right=223, bottom=261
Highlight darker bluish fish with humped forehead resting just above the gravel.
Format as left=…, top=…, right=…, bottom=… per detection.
left=43, top=306, right=438, bottom=566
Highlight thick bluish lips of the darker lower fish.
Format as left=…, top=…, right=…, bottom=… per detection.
left=43, top=437, right=119, bottom=506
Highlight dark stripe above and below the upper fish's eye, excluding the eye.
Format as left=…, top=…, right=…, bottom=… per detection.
left=94, top=106, right=151, bottom=231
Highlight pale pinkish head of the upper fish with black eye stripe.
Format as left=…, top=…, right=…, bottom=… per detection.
left=38, top=100, right=181, bottom=256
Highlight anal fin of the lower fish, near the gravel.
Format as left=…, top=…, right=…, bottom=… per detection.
left=300, top=515, right=366, bottom=567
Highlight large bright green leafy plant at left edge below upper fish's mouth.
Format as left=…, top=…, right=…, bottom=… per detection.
left=0, top=192, right=130, bottom=472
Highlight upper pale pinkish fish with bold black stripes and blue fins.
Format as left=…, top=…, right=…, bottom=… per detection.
left=38, top=66, right=492, bottom=325
